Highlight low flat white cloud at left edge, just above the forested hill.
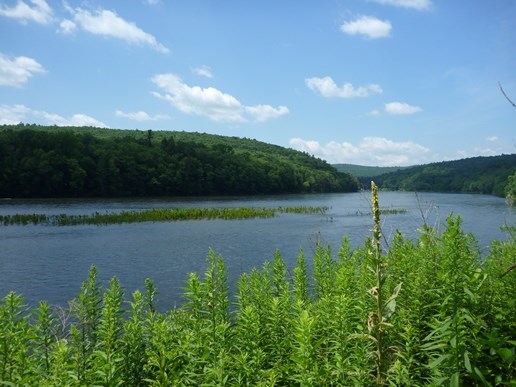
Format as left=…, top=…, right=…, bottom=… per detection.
left=0, top=105, right=108, bottom=128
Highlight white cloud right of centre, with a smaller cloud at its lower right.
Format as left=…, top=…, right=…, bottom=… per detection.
left=305, top=76, right=383, bottom=98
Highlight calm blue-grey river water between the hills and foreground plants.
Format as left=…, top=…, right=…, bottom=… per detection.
left=0, top=192, right=516, bottom=310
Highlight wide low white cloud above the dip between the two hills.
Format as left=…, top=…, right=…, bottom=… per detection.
left=289, top=137, right=430, bottom=166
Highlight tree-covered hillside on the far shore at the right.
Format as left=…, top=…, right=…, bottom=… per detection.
left=374, top=154, right=516, bottom=196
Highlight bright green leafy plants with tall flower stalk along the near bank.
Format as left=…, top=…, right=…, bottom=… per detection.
left=0, top=186, right=516, bottom=386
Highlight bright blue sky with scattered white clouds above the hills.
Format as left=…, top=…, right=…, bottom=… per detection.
left=0, top=0, right=516, bottom=166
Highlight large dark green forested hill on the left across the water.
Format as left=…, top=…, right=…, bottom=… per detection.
left=0, top=124, right=358, bottom=197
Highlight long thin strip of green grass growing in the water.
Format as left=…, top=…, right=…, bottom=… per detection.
left=0, top=206, right=329, bottom=226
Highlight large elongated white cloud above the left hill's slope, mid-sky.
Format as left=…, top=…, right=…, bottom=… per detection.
left=152, top=74, right=289, bottom=122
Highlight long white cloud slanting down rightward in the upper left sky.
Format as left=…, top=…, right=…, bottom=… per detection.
left=61, top=8, right=170, bottom=53
